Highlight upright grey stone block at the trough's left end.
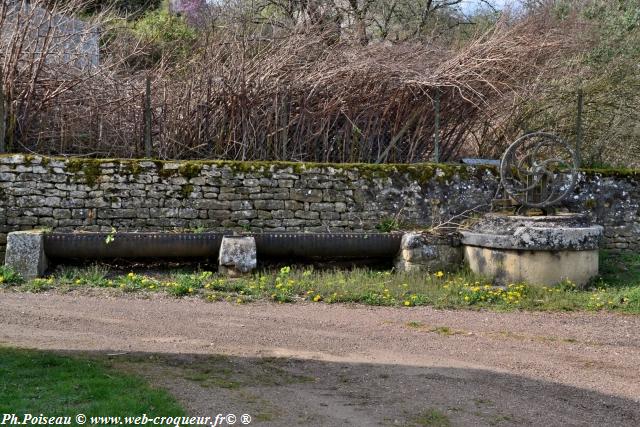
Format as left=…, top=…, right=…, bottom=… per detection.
left=5, top=230, right=48, bottom=280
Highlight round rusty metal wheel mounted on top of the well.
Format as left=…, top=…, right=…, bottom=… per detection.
left=500, top=132, right=578, bottom=210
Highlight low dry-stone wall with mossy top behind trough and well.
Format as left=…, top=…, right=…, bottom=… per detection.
left=0, top=155, right=640, bottom=256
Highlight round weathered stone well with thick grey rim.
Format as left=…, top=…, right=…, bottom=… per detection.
left=461, top=214, right=603, bottom=286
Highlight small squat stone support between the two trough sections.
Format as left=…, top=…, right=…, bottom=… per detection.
left=218, top=236, right=257, bottom=277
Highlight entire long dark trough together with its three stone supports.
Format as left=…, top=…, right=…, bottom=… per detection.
left=6, top=230, right=462, bottom=279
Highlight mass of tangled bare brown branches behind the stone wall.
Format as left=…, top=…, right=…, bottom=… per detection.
left=0, top=0, right=566, bottom=162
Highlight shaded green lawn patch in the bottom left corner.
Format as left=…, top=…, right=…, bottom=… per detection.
left=0, top=347, right=184, bottom=416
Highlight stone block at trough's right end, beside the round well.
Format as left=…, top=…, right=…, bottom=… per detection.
left=394, top=233, right=462, bottom=272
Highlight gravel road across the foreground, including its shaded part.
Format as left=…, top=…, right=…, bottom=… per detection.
left=0, top=291, right=640, bottom=426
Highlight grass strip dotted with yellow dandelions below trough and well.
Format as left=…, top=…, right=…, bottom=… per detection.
left=11, top=252, right=640, bottom=314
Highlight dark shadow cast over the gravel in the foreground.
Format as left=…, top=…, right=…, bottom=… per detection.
left=43, top=351, right=640, bottom=426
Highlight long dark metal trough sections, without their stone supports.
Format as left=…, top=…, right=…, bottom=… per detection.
left=44, top=232, right=402, bottom=259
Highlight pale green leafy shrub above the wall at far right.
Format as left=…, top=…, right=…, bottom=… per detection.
left=516, top=0, right=640, bottom=168
